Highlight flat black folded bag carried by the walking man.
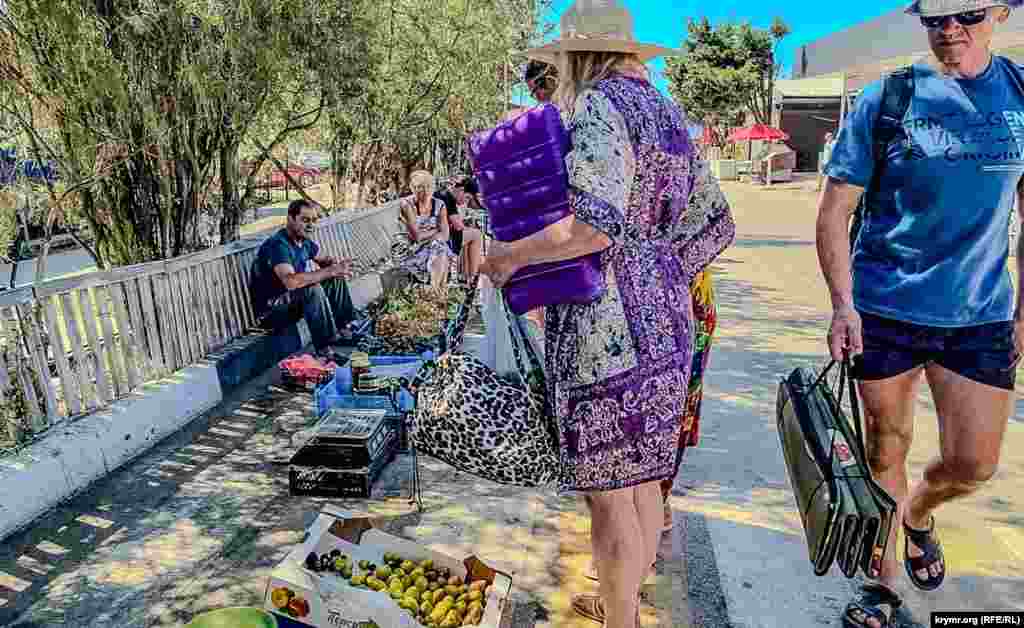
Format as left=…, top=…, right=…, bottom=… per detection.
left=776, top=360, right=896, bottom=578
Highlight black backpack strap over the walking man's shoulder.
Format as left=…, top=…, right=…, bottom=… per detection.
left=850, top=66, right=913, bottom=252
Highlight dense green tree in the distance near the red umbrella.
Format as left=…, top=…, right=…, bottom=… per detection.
left=666, top=17, right=790, bottom=148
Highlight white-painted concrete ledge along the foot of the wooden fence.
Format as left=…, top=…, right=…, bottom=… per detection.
left=0, top=268, right=382, bottom=539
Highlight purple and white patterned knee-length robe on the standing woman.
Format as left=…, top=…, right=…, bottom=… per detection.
left=545, top=76, right=735, bottom=491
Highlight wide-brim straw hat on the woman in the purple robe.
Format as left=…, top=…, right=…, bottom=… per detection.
left=523, top=0, right=682, bottom=64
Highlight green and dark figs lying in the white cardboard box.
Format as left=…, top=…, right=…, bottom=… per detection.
left=299, top=549, right=489, bottom=628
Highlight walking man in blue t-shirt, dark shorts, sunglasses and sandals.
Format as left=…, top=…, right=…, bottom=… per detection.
left=817, top=0, right=1024, bottom=628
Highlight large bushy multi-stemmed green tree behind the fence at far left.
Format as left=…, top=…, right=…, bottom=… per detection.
left=0, top=0, right=376, bottom=264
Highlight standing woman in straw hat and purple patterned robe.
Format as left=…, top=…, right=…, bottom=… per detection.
left=481, top=0, right=735, bottom=628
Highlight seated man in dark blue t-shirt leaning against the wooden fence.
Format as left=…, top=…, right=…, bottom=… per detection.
left=250, top=199, right=355, bottom=359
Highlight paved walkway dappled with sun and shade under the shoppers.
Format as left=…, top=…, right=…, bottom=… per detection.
left=0, top=174, right=1024, bottom=628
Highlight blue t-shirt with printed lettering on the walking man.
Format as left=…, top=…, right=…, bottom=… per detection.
left=825, top=56, right=1024, bottom=327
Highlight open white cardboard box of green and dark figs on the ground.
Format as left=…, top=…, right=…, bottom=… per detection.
left=264, top=506, right=512, bottom=628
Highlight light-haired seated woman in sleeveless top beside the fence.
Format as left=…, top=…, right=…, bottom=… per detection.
left=395, top=170, right=456, bottom=289
